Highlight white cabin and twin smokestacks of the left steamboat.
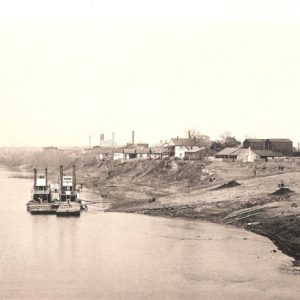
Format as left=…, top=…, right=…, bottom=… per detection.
left=32, top=169, right=52, bottom=203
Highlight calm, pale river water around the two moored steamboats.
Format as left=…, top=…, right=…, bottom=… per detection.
left=0, top=169, right=300, bottom=299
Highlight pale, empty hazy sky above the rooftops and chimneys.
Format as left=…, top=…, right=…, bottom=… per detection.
left=0, top=0, right=300, bottom=146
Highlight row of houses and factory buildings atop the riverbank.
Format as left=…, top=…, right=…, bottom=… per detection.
left=44, top=132, right=293, bottom=162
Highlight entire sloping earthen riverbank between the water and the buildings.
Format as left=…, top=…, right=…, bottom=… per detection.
left=0, top=149, right=300, bottom=264
